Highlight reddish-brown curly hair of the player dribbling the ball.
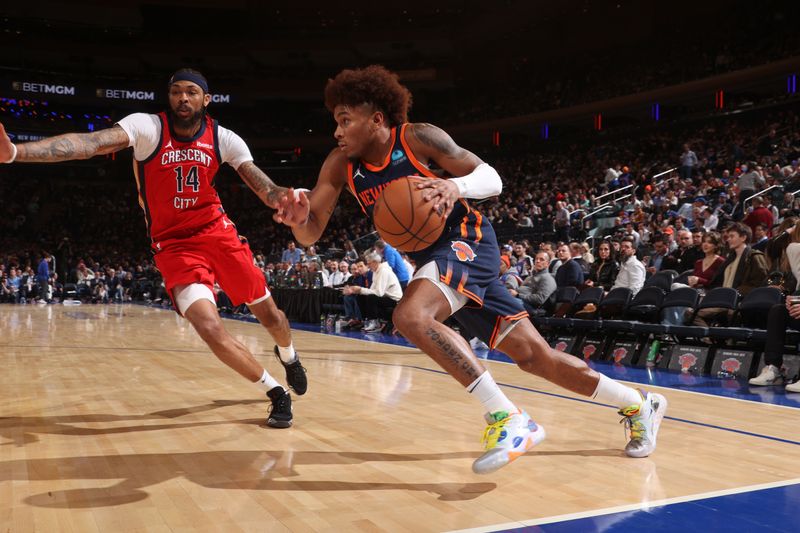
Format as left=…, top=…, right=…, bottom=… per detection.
left=325, top=65, right=411, bottom=127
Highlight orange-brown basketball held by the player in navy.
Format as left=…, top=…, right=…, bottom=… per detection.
left=372, top=176, right=445, bottom=252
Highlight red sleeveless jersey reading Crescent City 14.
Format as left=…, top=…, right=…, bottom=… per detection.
left=133, top=113, right=225, bottom=243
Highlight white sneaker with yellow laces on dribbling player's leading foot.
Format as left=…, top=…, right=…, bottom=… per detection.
left=472, top=411, right=546, bottom=474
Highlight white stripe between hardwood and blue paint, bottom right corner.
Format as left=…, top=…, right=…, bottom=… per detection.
left=440, top=478, right=800, bottom=533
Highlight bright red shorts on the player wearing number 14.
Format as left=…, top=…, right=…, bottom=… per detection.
left=153, top=217, right=270, bottom=305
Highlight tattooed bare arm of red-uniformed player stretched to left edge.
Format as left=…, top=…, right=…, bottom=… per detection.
left=0, top=124, right=130, bottom=163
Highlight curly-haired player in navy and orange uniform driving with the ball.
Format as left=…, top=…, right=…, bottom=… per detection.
left=275, top=66, right=667, bottom=474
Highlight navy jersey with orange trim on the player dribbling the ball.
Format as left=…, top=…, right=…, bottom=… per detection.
left=347, top=124, right=483, bottom=263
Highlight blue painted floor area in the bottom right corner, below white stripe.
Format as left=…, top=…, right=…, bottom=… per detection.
left=500, top=485, right=800, bottom=533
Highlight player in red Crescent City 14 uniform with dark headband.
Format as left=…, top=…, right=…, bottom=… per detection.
left=0, top=69, right=307, bottom=428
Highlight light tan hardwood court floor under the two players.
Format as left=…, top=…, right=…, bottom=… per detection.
left=0, top=305, right=800, bottom=532
